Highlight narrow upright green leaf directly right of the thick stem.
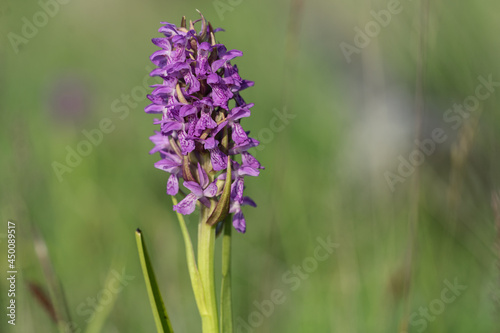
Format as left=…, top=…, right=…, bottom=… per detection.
left=220, top=215, right=233, bottom=333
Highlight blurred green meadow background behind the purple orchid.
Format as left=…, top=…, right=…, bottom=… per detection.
left=0, top=0, right=500, bottom=333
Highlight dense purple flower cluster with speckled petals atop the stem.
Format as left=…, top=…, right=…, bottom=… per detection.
left=145, top=15, right=263, bottom=232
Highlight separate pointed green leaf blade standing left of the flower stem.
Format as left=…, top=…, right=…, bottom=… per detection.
left=135, top=229, right=173, bottom=333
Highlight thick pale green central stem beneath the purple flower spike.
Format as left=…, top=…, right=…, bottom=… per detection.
left=198, top=202, right=219, bottom=333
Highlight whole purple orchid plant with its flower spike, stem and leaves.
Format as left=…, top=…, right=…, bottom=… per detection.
left=136, top=14, right=264, bottom=333
